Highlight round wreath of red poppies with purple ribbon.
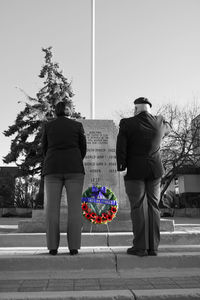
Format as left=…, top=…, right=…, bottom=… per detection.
left=82, top=185, right=118, bottom=224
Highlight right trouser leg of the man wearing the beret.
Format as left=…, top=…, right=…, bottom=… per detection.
left=146, top=178, right=160, bottom=251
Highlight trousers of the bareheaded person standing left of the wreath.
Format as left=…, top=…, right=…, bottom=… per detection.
left=44, top=173, right=84, bottom=250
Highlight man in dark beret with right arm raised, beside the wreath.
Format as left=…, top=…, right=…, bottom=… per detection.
left=116, top=97, right=170, bottom=256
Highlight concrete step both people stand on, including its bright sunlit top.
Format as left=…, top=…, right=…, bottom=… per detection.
left=0, top=245, right=200, bottom=279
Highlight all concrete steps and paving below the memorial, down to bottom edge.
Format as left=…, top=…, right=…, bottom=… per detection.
left=0, top=218, right=200, bottom=300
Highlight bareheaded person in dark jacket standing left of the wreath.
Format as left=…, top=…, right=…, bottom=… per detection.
left=42, top=102, right=86, bottom=255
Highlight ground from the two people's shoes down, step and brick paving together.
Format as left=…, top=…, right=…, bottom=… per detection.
left=0, top=246, right=200, bottom=300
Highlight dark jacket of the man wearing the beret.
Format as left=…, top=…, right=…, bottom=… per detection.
left=116, top=112, right=170, bottom=180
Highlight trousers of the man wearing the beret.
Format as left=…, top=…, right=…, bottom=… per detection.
left=125, top=178, right=160, bottom=251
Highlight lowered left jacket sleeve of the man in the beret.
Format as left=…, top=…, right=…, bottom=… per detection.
left=116, top=119, right=127, bottom=171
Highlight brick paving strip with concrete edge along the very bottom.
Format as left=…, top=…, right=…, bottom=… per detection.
left=0, top=272, right=200, bottom=300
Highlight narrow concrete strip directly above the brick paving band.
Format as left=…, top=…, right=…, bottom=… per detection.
left=0, top=268, right=200, bottom=280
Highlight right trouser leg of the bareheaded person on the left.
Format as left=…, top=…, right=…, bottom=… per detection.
left=65, top=174, right=84, bottom=250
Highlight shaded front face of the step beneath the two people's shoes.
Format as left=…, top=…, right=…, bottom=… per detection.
left=0, top=249, right=200, bottom=272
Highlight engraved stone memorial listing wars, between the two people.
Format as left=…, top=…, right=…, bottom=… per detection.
left=81, top=120, right=127, bottom=207
